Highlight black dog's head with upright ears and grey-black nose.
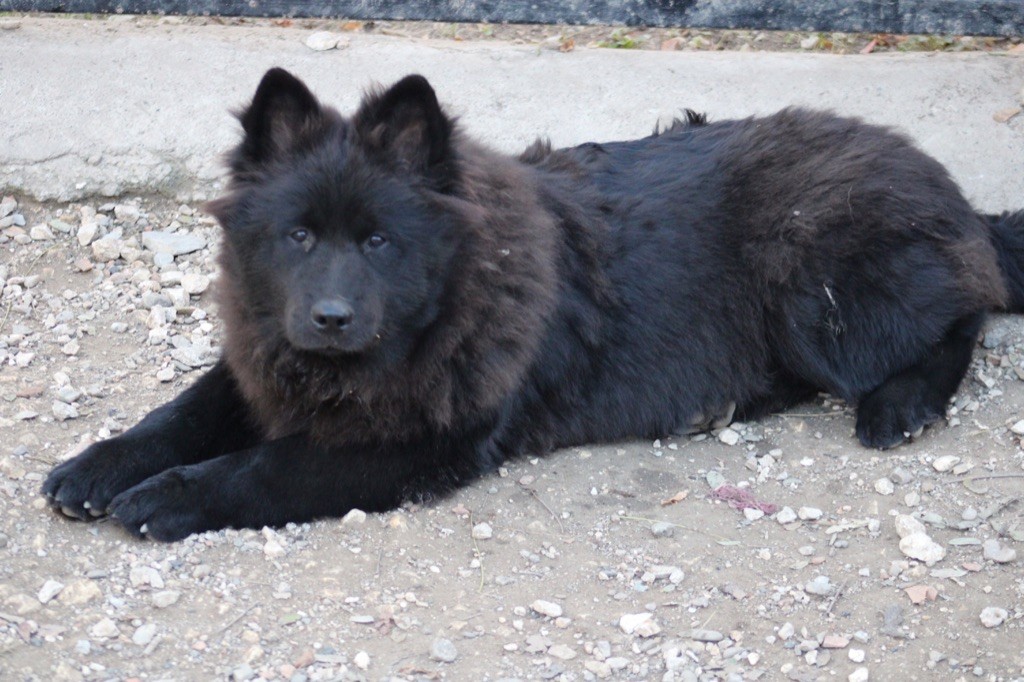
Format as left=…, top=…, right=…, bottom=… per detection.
left=208, top=69, right=457, bottom=359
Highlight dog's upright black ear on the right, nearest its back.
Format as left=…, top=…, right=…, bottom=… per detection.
left=353, top=75, right=454, bottom=171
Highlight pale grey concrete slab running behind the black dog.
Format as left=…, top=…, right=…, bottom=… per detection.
left=0, top=17, right=1024, bottom=210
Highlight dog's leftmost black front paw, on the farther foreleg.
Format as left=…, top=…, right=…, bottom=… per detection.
left=42, top=438, right=150, bottom=520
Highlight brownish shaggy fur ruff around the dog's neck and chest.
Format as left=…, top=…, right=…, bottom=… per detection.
left=219, top=135, right=558, bottom=443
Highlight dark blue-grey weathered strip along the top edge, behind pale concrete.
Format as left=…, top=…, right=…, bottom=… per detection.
left=0, top=0, right=1024, bottom=36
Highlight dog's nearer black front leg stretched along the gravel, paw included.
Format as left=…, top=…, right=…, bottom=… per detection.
left=111, top=434, right=489, bottom=541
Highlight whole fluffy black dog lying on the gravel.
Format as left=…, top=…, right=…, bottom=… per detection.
left=43, top=70, right=1024, bottom=540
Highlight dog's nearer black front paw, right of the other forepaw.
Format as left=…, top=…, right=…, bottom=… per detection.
left=110, top=467, right=216, bottom=542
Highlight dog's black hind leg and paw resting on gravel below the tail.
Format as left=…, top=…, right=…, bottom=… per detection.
left=857, top=312, right=985, bottom=449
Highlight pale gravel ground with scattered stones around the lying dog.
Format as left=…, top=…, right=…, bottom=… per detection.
left=0, top=187, right=1024, bottom=681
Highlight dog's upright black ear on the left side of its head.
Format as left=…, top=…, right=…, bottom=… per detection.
left=239, top=68, right=323, bottom=163
